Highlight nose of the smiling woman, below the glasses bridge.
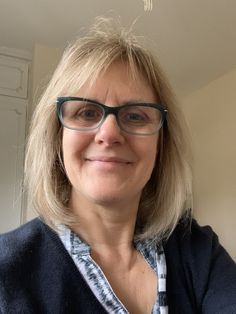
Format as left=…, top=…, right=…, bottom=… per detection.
left=95, top=114, right=125, bottom=146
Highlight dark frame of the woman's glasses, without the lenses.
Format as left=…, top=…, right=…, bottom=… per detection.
left=56, top=96, right=168, bottom=135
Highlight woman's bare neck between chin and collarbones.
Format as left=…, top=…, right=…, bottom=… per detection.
left=70, top=191, right=138, bottom=253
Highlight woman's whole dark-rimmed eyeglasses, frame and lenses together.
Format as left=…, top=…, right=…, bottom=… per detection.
left=56, top=97, right=167, bottom=135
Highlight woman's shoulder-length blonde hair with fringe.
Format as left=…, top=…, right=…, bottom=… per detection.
left=25, top=18, right=191, bottom=238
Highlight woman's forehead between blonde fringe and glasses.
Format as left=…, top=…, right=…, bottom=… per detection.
left=76, top=61, right=157, bottom=102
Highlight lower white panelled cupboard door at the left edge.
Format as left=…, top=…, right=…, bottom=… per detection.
left=0, top=96, right=27, bottom=233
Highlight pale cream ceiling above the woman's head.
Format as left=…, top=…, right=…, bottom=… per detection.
left=0, top=0, right=236, bottom=95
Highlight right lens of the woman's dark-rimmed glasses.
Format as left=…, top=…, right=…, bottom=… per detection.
left=119, top=105, right=162, bottom=135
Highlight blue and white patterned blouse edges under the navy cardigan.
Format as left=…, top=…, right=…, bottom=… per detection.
left=59, top=225, right=168, bottom=314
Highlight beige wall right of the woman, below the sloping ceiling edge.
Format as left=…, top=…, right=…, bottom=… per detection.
left=183, top=69, right=236, bottom=260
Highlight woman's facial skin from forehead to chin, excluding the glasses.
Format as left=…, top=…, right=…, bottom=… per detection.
left=62, top=62, right=158, bottom=206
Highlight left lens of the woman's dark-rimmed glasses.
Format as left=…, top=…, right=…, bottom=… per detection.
left=61, top=100, right=103, bottom=130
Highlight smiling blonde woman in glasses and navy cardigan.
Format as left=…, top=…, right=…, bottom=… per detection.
left=0, top=19, right=236, bottom=314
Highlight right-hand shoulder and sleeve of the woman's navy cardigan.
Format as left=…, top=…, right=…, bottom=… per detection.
left=164, top=219, right=236, bottom=313
